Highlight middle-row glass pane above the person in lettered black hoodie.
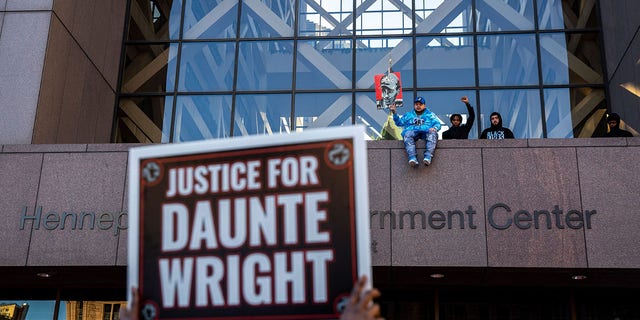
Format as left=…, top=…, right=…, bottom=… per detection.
left=478, top=34, right=538, bottom=86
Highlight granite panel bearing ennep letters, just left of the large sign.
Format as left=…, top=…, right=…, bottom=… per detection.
left=28, top=153, right=127, bottom=266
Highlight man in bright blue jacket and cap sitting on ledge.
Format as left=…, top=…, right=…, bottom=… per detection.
left=389, top=97, right=440, bottom=167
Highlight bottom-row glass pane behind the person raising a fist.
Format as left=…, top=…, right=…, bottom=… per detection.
left=416, top=90, right=478, bottom=139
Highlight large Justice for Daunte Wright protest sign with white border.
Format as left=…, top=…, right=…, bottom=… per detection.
left=128, top=126, right=371, bottom=319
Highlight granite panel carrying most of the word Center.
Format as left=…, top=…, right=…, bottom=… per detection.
left=482, top=148, right=587, bottom=268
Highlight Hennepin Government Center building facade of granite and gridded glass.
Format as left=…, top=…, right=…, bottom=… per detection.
left=0, top=0, right=640, bottom=319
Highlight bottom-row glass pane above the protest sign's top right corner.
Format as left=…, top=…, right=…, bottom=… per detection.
left=294, top=93, right=352, bottom=131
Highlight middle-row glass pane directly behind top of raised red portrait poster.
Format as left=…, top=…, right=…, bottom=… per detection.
left=356, top=38, right=413, bottom=90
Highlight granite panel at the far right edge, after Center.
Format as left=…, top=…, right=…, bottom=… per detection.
left=578, top=147, right=640, bottom=268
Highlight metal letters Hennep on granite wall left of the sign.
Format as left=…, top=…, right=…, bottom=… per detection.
left=20, top=206, right=129, bottom=236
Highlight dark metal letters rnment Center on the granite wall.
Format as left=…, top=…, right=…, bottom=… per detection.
left=369, top=203, right=597, bottom=230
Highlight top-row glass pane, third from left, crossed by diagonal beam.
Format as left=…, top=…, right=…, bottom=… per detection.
left=240, top=0, right=295, bottom=38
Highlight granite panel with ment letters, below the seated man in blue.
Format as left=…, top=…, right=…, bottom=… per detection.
left=391, top=143, right=487, bottom=266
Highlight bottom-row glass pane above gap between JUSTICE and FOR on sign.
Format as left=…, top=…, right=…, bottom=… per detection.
left=233, top=94, right=293, bottom=136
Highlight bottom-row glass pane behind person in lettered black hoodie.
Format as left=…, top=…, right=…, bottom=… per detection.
left=478, top=89, right=543, bottom=139
